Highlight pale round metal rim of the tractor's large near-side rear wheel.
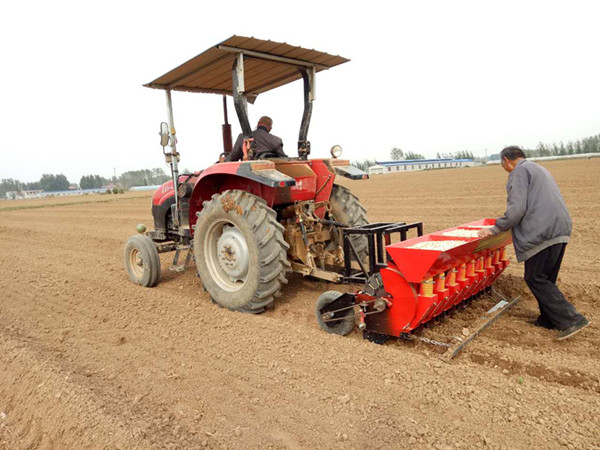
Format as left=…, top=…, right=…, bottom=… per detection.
left=204, top=220, right=250, bottom=292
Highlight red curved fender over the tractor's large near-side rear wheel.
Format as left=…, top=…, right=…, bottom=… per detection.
left=190, top=161, right=296, bottom=232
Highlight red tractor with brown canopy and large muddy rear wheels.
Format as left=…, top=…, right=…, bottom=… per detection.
left=125, top=36, right=368, bottom=313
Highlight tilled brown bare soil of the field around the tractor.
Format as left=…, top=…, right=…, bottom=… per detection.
left=0, top=159, right=600, bottom=449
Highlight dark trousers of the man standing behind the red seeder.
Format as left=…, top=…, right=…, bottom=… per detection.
left=525, top=244, right=583, bottom=330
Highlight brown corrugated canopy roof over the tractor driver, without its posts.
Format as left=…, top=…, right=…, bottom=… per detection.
left=144, top=36, right=349, bottom=102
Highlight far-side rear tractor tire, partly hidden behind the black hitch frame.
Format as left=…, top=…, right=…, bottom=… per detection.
left=329, top=184, right=369, bottom=261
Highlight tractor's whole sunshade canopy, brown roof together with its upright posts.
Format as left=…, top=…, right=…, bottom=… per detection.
left=145, top=36, right=348, bottom=159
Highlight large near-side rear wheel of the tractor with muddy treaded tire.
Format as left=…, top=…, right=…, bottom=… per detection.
left=194, top=190, right=291, bottom=314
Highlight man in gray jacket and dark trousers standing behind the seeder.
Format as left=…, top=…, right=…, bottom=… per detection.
left=479, top=147, right=590, bottom=340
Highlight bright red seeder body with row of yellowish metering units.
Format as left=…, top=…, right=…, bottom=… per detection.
left=366, top=219, right=511, bottom=336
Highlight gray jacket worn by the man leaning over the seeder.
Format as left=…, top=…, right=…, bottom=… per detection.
left=491, top=159, right=573, bottom=262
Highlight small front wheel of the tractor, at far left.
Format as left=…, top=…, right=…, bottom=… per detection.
left=124, top=234, right=160, bottom=287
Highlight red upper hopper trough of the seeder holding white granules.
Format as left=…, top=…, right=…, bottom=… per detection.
left=386, top=219, right=511, bottom=283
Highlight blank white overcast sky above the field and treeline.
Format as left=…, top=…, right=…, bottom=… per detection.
left=0, top=0, right=600, bottom=182
